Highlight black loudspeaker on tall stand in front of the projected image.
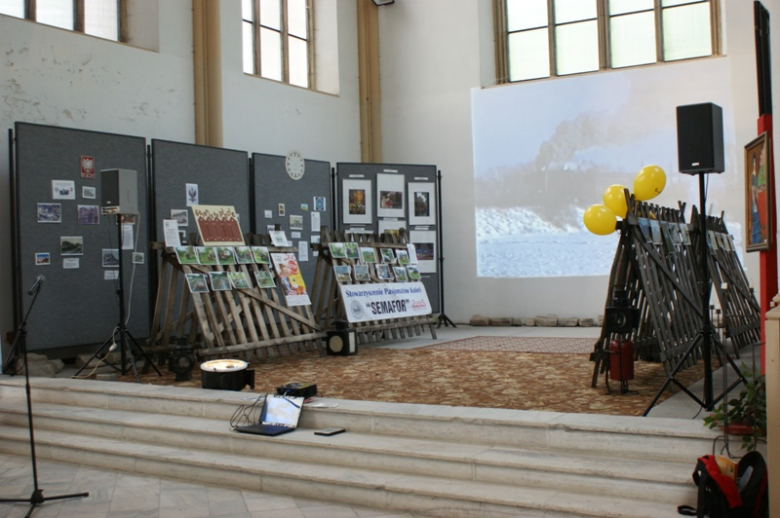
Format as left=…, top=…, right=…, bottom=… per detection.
left=677, top=103, right=725, bottom=174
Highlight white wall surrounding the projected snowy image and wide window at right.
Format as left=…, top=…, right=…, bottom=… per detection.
left=379, top=0, right=780, bottom=322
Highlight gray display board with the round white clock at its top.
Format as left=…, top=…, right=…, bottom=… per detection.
left=252, top=153, right=333, bottom=292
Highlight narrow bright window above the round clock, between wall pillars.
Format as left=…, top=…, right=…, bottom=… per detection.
left=242, top=0, right=314, bottom=88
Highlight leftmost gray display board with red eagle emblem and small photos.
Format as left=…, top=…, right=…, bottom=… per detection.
left=13, top=123, right=149, bottom=351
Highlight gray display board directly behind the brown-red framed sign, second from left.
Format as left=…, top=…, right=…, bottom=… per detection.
left=152, top=140, right=252, bottom=246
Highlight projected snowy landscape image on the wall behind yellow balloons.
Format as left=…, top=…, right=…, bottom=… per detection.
left=472, top=60, right=744, bottom=277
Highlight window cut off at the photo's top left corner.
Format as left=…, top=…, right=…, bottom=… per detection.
left=0, top=0, right=125, bottom=41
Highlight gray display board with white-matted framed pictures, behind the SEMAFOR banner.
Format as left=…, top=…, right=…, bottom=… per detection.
left=336, top=163, right=440, bottom=313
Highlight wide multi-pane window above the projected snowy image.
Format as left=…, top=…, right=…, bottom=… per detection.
left=495, top=0, right=719, bottom=82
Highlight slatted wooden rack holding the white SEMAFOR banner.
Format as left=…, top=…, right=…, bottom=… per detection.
left=312, top=226, right=436, bottom=344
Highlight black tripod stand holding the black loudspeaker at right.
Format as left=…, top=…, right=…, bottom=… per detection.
left=642, top=173, right=747, bottom=416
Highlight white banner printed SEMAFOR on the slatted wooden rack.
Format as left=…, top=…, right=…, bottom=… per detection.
left=339, top=282, right=431, bottom=322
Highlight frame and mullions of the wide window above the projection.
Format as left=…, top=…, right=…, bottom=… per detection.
left=493, top=0, right=722, bottom=84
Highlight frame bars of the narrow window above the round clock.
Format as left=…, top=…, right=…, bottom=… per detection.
left=241, top=0, right=316, bottom=90
